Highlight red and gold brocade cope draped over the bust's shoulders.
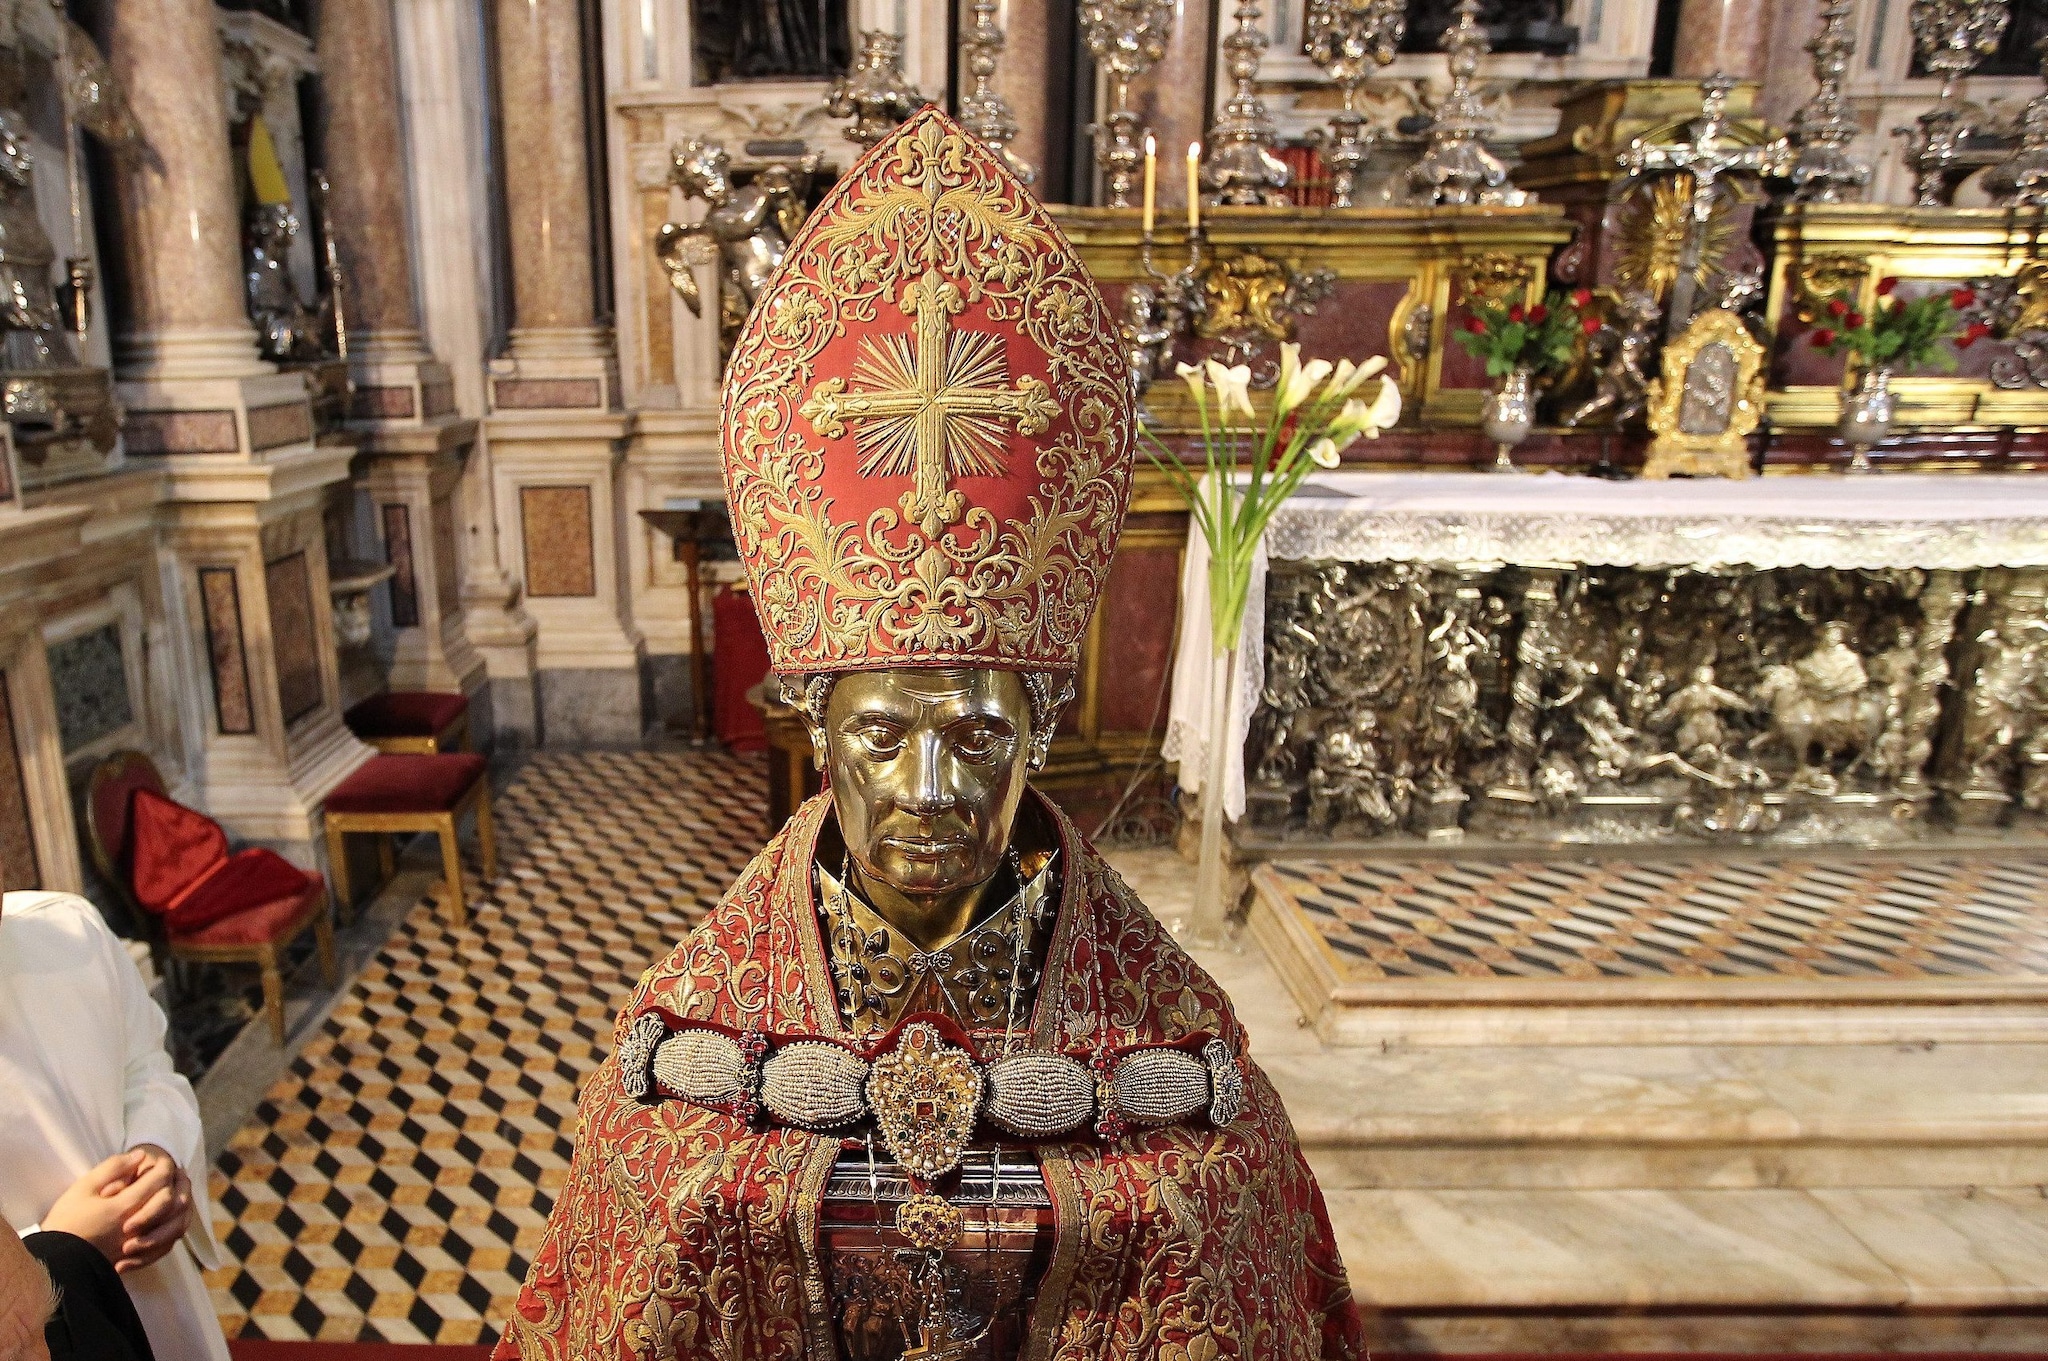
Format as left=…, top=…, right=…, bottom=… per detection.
left=496, top=796, right=1364, bottom=1361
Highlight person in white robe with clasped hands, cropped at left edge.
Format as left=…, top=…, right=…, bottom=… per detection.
left=0, top=892, right=227, bottom=1361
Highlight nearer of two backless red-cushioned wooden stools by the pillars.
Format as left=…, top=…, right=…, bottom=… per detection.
left=324, top=751, right=498, bottom=925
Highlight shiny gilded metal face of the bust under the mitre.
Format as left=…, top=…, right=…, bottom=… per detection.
left=823, top=669, right=1030, bottom=898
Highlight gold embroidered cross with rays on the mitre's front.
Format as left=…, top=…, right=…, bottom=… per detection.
left=799, top=270, right=1059, bottom=536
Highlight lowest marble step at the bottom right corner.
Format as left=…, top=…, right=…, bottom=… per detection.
left=1327, top=1187, right=2048, bottom=1355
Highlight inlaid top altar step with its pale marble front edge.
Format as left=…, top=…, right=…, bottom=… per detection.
left=1251, top=851, right=2048, bottom=1048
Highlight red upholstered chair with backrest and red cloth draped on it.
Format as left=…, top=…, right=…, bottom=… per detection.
left=86, top=751, right=336, bottom=1046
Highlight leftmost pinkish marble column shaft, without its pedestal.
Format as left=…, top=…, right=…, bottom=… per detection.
left=100, top=0, right=270, bottom=382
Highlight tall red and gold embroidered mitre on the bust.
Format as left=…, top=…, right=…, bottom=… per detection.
left=723, top=104, right=1135, bottom=675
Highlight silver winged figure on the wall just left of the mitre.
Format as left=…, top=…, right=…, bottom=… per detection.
left=653, top=137, right=817, bottom=347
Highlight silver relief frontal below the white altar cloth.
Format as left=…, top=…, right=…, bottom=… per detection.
left=1245, top=561, right=2048, bottom=841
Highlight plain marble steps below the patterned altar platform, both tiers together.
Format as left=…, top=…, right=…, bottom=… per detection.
left=1114, top=853, right=2048, bottom=1355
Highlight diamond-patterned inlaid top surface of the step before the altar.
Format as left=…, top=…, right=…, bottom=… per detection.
left=1268, top=855, right=2048, bottom=980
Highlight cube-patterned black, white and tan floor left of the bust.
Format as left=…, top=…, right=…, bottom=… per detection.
left=207, top=753, right=766, bottom=1345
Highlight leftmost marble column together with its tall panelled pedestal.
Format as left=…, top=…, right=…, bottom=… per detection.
left=102, top=0, right=371, bottom=864
